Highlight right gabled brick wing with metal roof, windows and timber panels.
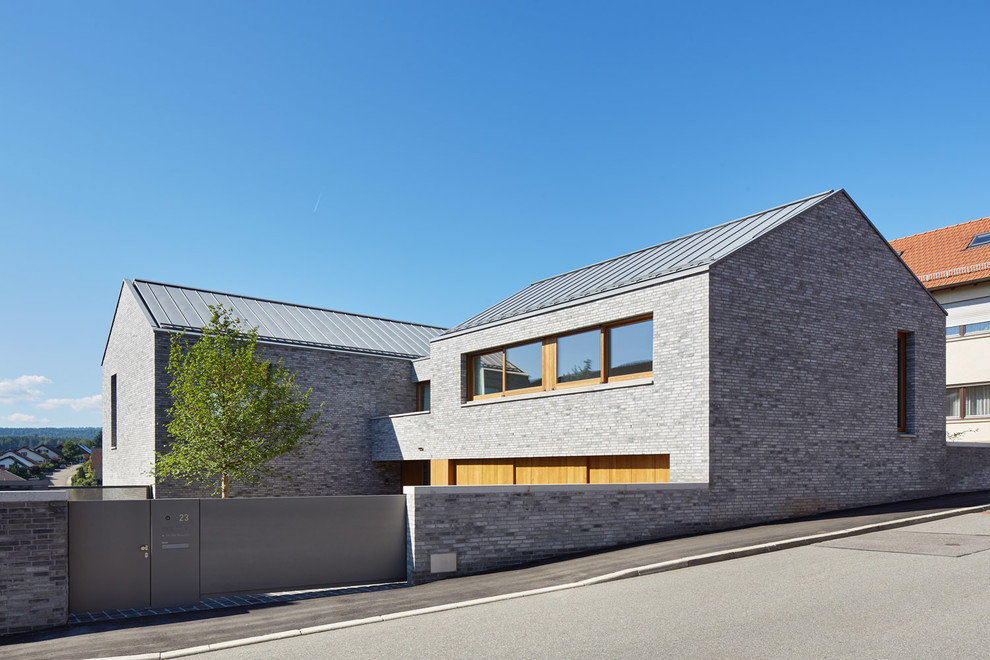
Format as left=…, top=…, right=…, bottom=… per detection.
left=382, top=190, right=944, bottom=519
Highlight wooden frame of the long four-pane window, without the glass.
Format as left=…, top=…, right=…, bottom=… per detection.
left=466, top=314, right=653, bottom=401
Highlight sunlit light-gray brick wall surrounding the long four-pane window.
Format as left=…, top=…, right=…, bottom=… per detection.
left=372, top=273, right=708, bottom=482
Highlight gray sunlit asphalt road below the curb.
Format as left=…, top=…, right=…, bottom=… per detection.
left=197, top=513, right=990, bottom=660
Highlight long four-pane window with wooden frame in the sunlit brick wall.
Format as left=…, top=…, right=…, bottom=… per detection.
left=468, top=319, right=653, bottom=399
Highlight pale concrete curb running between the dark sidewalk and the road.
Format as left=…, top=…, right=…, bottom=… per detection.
left=93, top=504, right=990, bottom=660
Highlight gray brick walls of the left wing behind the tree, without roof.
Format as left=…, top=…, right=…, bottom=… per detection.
left=103, top=286, right=416, bottom=497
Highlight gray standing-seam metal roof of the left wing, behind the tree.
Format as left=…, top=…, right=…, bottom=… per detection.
left=126, top=280, right=443, bottom=358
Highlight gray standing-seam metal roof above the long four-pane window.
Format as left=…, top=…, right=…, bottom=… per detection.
left=445, top=190, right=836, bottom=334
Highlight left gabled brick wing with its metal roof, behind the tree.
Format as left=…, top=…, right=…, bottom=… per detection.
left=102, top=280, right=441, bottom=497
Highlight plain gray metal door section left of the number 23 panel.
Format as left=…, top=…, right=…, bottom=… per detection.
left=69, top=500, right=151, bottom=613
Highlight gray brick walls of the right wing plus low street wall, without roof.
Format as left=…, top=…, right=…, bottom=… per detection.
left=396, top=193, right=952, bottom=580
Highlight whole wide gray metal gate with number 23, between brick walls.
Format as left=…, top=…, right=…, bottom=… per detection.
left=69, top=495, right=406, bottom=613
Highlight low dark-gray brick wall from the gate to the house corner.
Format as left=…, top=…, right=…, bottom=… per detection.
left=404, top=484, right=711, bottom=583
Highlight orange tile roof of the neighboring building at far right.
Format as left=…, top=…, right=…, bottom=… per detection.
left=890, top=218, right=990, bottom=289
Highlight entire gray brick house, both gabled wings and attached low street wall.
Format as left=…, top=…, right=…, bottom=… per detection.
left=103, top=190, right=976, bottom=581
